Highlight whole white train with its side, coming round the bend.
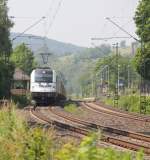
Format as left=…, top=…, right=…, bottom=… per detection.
left=30, top=68, right=66, bottom=104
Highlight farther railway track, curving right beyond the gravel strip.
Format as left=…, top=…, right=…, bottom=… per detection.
left=81, top=102, right=150, bottom=123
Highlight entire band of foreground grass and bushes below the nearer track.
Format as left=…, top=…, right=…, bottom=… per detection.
left=0, top=105, right=143, bottom=160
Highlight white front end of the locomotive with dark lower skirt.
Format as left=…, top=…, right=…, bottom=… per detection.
left=30, top=69, right=56, bottom=104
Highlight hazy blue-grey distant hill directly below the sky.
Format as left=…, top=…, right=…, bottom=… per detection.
left=11, top=33, right=86, bottom=56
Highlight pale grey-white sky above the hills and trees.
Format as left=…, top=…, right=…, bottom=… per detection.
left=8, top=0, right=138, bottom=47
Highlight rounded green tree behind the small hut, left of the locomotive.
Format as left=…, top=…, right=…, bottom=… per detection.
left=11, top=43, right=36, bottom=74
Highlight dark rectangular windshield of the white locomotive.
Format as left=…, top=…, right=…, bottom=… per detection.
left=35, top=70, right=53, bottom=83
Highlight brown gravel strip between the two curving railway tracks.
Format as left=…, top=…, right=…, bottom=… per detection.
left=53, top=106, right=150, bottom=134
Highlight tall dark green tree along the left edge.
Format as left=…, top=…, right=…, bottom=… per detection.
left=0, top=0, right=14, bottom=98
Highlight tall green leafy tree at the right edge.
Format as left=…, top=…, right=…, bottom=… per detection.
left=134, top=0, right=150, bottom=80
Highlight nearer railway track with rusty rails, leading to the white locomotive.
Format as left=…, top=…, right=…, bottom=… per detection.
left=30, top=109, right=150, bottom=154
